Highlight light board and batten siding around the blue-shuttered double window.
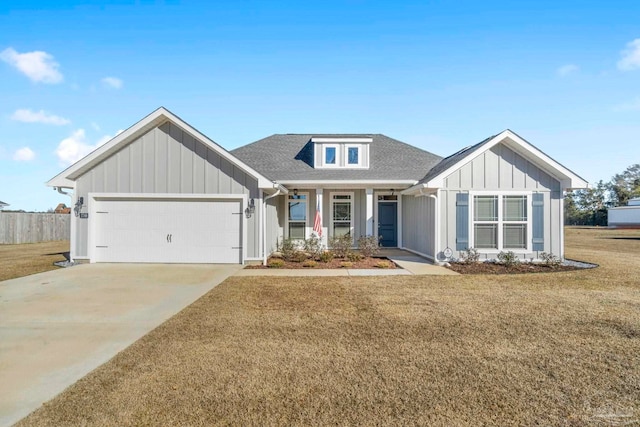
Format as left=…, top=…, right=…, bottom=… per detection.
left=437, top=144, right=564, bottom=259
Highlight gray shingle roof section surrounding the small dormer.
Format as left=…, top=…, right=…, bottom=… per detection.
left=231, top=134, right=442, bottom=181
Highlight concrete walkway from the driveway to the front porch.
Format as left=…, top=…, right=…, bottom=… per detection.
left=235, top=249, right=458, bottom=277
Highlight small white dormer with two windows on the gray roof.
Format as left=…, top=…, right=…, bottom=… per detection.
left=311, top=136, right=373, bottom=169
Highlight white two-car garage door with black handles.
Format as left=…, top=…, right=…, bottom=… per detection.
left=91, top=199, right=242, bottom=264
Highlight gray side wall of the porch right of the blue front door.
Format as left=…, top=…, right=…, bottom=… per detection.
left=402, top=196, right=436, bottom=258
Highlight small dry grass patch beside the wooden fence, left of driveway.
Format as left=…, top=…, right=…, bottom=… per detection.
left=0, top=241, right=69, bottom=282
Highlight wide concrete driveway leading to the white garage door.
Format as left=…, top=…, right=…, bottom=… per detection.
left=0, top=264, right=242, bottom=426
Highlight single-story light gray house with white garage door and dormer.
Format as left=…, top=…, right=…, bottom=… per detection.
left=47, top=108, right=587, bottom=263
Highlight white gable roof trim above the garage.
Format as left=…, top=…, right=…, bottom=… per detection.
left=47, top=107, right=274, bottom=188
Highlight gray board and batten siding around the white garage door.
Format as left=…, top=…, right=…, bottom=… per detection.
left=72, top=122, right=261, bottom=258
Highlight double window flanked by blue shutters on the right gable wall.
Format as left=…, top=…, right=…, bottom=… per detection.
left=473, top=195, right=529, bottom=250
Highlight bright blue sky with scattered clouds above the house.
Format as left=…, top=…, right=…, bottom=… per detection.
left=0, top=0, right=640, bottom=210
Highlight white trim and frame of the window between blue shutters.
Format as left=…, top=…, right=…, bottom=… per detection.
left=469, top=191, right=533, bottom=254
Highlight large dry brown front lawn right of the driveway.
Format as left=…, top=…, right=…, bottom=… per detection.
left=15, top=229, right=640, bottom=426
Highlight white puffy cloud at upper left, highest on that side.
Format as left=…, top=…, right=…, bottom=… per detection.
left=0, top=47, right=63, bottom=83
